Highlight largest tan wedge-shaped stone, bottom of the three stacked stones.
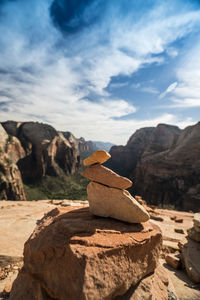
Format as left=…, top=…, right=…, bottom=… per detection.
left=87, top=182, right=149, bottom=223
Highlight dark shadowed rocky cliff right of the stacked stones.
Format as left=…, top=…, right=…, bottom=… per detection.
left=106, top=122, right=200, bottom=211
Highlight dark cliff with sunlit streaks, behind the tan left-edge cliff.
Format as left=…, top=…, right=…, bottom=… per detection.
left=2, top=121, right=80, bottom=183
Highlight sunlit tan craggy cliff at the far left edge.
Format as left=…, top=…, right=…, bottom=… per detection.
left=0, top=124, right=26, bottom=200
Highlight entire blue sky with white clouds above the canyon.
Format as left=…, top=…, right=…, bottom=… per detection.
left=0, top=0, right=200, bottom=144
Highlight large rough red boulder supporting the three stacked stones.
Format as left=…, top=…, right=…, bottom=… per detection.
left=10, top=208, right=162, bottom=300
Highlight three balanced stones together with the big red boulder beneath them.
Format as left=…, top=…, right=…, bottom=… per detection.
left=9, top=151, right=169, bottom=300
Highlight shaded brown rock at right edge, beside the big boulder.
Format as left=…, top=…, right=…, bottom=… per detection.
left=181, top=239, right=200, bottom=283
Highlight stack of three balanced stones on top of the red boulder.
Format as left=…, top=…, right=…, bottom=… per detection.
left=82, top=150, right=149, bottom=223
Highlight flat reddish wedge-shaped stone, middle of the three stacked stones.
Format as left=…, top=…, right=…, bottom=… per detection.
left=82, top=164, right=132, bottom=190
